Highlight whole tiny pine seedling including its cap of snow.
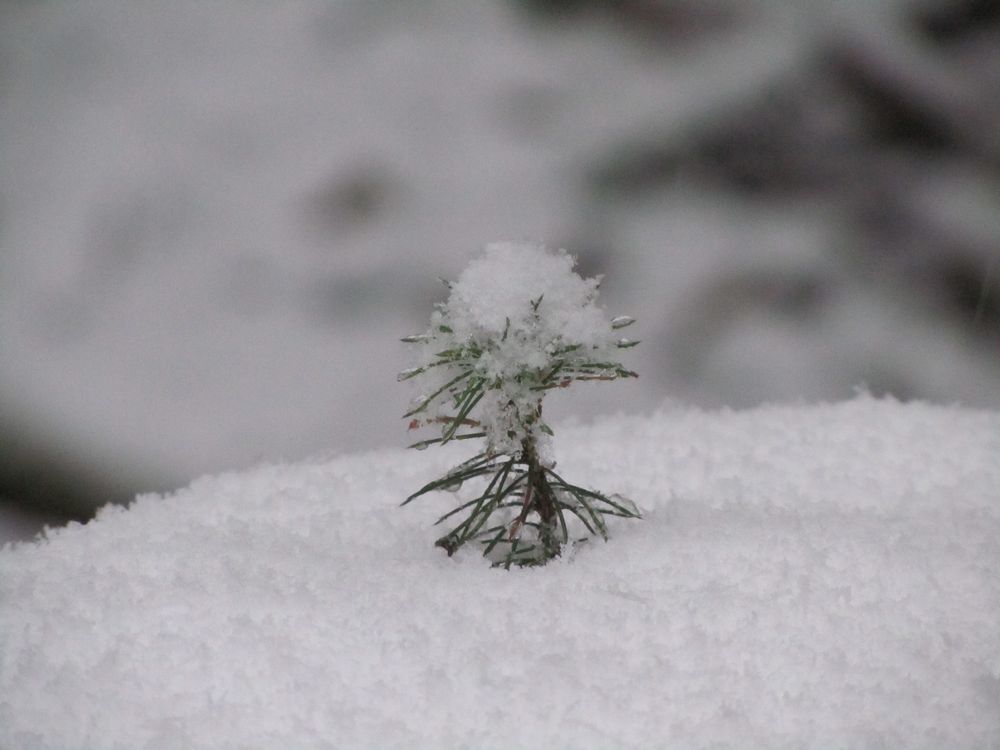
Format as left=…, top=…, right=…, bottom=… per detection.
left=399, top=243, right=639, bottom=568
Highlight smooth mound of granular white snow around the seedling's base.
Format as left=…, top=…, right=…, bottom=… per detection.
left=0, top=397, right=1000, bottom=750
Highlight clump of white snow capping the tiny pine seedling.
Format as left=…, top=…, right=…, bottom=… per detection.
left=406, top=242, right=624, bottom=462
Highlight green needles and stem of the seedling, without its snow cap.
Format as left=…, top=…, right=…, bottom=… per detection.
left=399, top=248, right=640, bottom=568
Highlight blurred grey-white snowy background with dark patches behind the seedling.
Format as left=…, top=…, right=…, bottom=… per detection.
left=0, top=0, right=1000, bottom=542
